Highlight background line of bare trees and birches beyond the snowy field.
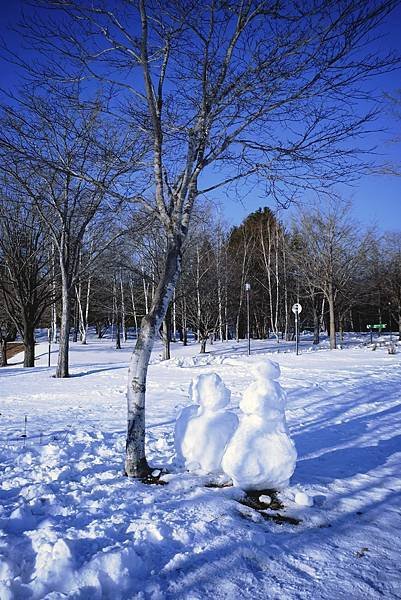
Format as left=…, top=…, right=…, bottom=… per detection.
left=0, top=198, right=401, bottom=368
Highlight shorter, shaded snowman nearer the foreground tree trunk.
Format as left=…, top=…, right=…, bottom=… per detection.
left=175, top=373, right=238, bottom=473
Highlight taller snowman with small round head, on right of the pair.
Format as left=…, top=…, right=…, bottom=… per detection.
left=222, top=361, right=297, bottom=490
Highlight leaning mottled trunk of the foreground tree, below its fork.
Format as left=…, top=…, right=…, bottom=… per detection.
left=125, top=236, right=182, bottom=477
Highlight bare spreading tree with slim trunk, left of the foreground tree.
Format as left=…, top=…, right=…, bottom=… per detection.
left=0, top=88, right=138, bottom=377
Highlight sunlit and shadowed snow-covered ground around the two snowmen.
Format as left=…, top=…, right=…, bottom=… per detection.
left=0, top=338, right=401, bottom=600
